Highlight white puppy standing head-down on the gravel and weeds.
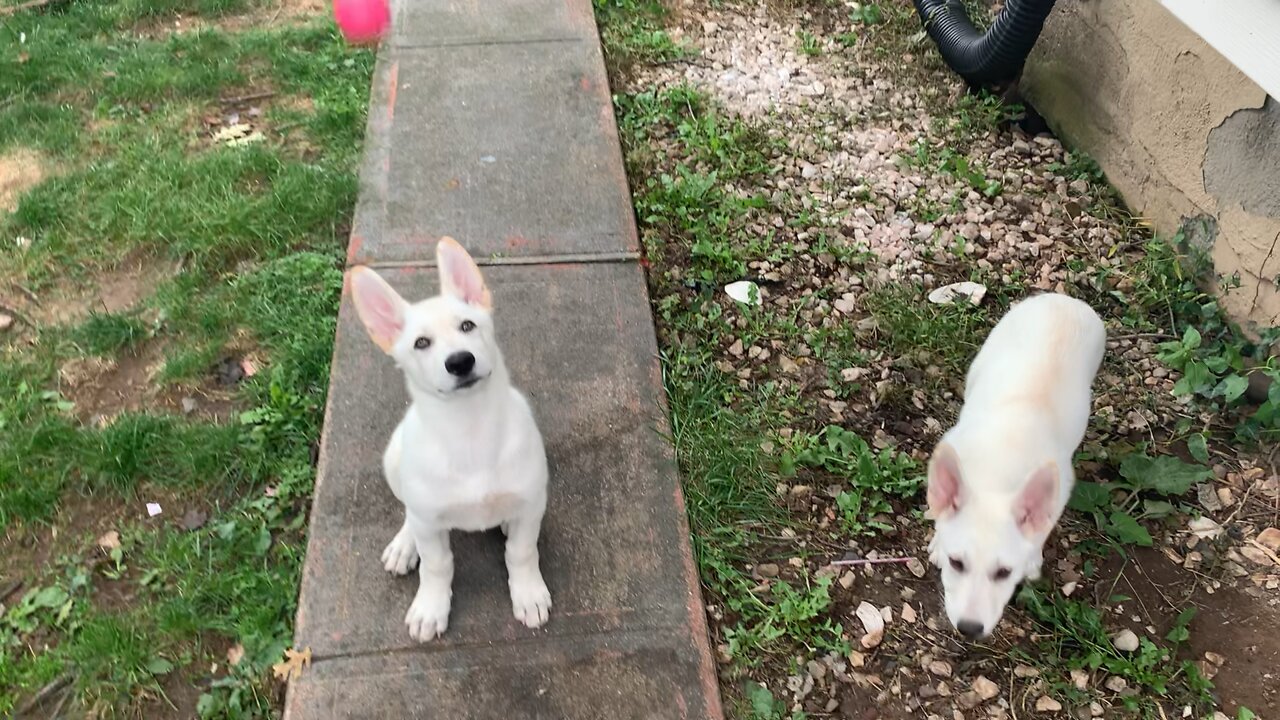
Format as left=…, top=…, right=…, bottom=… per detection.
left=928, top=288, right=1106, bottom=639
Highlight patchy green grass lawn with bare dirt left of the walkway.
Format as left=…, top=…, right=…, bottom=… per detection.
left=0, top=0, right=372, bottom=717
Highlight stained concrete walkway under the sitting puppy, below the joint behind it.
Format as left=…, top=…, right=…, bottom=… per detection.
left=287, top=262, right=721, bottom=719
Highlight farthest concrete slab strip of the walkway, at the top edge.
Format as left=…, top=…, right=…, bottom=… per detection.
left=390, top=0, right=596, bottom=47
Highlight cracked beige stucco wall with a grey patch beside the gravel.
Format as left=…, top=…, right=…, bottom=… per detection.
left=1020, top=0, right=1280, bottom=327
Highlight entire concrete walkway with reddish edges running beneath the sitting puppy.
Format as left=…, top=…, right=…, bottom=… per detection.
left=285, top=0, right=722, bottom=720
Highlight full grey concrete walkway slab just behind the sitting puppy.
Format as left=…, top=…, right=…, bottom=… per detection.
left=349, top=38, right=639, bottom=264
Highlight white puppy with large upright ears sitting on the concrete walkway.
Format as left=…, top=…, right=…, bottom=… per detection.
left=351, top=238, right=552, bottom=642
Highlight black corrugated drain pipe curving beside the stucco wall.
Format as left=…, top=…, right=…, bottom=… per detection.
left=911, top=0, right=1053, bottom=87
